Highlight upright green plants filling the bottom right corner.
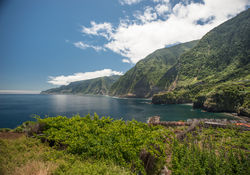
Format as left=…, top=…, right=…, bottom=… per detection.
left=170, top=128, right=250, bottom=175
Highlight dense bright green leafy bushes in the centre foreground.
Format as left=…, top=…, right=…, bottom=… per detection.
left=38, top=114, right=170, bottom=174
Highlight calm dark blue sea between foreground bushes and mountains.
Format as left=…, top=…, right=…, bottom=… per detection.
left=0, top=94, right=232, bottom=128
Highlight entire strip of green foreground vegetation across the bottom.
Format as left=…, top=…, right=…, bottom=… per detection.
left=0, top=114, right=250, bottom=175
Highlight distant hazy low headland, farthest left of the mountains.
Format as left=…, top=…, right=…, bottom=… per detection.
left=41, top=75, right=120, bottom=95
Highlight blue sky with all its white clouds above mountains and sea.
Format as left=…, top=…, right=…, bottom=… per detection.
left=0, top=0, right=250, bottom=93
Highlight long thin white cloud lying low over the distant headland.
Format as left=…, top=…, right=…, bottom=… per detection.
left=48, top=69, right=123, bottom=85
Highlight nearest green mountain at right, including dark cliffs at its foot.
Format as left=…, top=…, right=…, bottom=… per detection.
left=152, top=9, right=250, bottom=114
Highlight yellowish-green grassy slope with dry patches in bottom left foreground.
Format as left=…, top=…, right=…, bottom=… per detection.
left=0, top=136, right=131, bottom=175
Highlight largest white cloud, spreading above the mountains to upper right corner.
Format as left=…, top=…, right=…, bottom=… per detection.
left=83, top=0, right=250, bottom=64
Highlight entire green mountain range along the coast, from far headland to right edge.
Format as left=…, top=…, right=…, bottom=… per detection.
left=42, top=9, right=250, bottom=116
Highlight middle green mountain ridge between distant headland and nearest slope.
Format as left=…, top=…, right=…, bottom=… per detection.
left=110, top=41, right=198, bottom=97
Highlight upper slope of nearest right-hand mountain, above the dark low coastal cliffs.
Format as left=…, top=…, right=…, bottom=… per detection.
left=157, top=9, right=250, bottom=90
